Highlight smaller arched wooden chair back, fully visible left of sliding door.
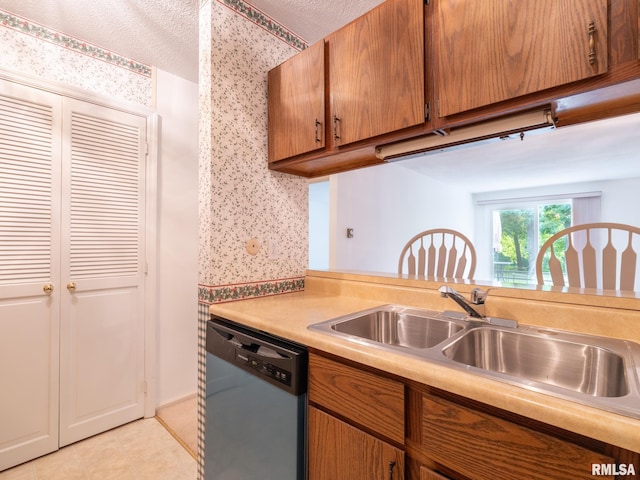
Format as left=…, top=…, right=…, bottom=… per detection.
left=398, top=228, right=476, bottom=279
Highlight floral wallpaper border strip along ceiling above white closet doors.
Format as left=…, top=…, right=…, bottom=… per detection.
left=0, top=9, right=151, bottom=78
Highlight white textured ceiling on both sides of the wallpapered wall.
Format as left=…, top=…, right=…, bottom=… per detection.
left=0, top=0, right=382, bottom=82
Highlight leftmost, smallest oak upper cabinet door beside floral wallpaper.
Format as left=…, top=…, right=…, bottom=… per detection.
left=268, top=41, right=325, bottom=162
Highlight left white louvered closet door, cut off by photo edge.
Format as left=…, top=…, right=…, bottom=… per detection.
left=0, top=80, right=62, bottom=470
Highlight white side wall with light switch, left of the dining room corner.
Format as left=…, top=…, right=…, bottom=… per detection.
left=331, top=163, right=474, bottom=273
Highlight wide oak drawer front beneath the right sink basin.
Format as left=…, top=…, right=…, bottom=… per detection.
left=422, top=394, right=615, bottom=480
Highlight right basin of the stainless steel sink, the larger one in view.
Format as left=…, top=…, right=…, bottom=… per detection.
left=443, top=327, right=629, bottom=397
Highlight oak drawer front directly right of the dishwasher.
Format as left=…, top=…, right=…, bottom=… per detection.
left=309, top=354, right=405, bottom=443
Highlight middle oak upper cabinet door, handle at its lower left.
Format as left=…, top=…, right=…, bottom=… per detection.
left=328, top=0, right=425, bottom=146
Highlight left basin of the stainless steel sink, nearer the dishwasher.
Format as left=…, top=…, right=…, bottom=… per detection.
left=317, top=306, right=464, bottom=349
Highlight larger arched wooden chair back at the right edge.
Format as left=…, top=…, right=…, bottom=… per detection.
left=536, top=223, right=640, bottom=291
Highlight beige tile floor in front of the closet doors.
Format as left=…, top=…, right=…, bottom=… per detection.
left=0, top=418, right=197, bottom=480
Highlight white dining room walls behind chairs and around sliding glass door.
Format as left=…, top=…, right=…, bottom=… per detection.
left=331, top=163, right=640, bottom=280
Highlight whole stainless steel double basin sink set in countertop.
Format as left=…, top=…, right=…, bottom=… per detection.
left=309, top=305, right=640, bottom=419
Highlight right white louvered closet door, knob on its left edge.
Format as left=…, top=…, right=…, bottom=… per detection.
left=60, top=98, right=146, bottom=446
